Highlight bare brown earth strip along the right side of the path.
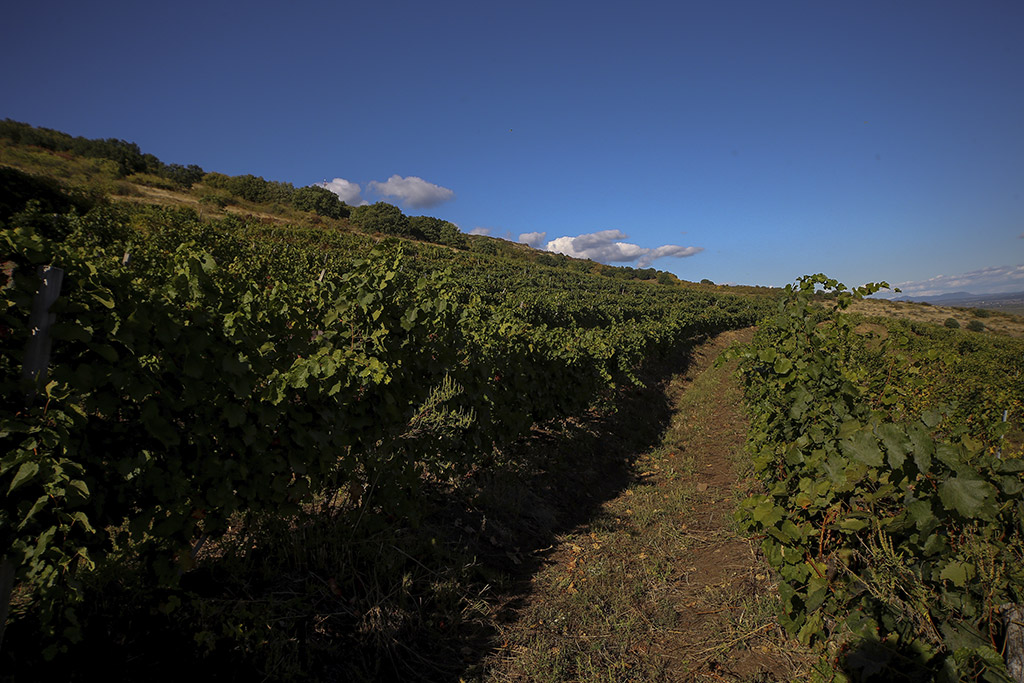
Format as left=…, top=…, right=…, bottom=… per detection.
left=652, top=330, right=797, bottom=681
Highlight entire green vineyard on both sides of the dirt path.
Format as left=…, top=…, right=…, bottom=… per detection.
left=0, top=135, right=1024, bottom=681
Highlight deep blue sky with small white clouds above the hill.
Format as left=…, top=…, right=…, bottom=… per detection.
left=0, top=0, right=1024, bottom=294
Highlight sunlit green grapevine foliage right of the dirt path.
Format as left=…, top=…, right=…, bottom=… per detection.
left=737, top=274, right=1024, bottom=681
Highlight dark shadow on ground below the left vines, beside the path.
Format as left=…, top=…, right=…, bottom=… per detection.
left=0, top=339, right=704, bottom=681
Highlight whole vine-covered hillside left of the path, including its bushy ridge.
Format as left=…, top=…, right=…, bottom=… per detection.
left=0, top=122, right=769, bottom=680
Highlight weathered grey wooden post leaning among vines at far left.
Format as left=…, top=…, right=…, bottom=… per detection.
left=0, top=265, right=63, bottom=646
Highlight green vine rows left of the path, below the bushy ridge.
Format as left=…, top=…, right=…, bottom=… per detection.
left=0, top=184, right=765, bottom=679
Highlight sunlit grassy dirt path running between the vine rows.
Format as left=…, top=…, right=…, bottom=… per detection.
left=489, top=330, right=809, bottom=681
